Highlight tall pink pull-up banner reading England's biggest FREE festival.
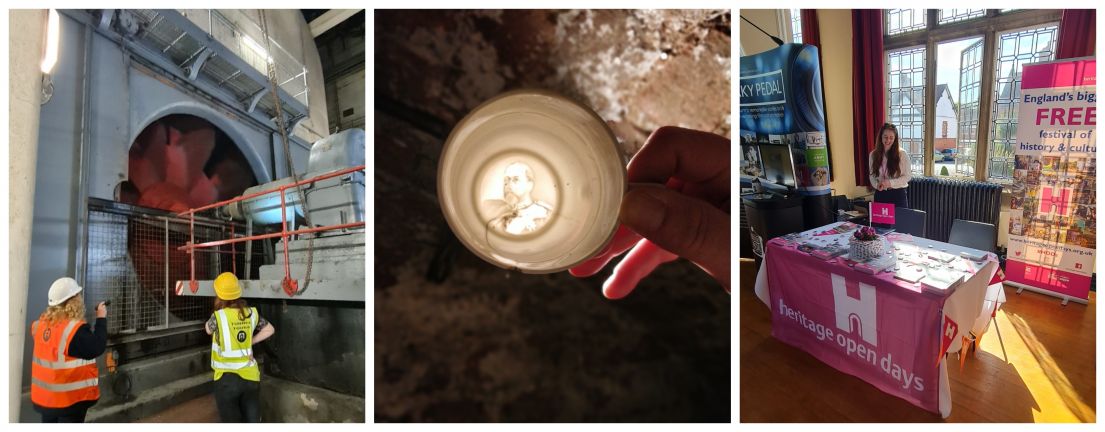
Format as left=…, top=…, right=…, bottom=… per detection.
left=1006, top=59, right=1097, bottom=299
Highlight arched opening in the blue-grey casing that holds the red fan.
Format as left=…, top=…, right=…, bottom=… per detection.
left=109, top=114, right=261, bottom=331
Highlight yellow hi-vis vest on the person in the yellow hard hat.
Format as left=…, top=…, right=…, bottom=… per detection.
left=211, top=307, right=261, bottom=381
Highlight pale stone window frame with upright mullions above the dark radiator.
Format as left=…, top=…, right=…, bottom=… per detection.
left=883, top=9, right=1062, bottom=183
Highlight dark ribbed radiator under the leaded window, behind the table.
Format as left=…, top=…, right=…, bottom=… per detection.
left=909, top=177, right=1001, bottom=242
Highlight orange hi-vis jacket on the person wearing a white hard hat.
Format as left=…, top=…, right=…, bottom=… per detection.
left=31, top=320, right=99, bottom=408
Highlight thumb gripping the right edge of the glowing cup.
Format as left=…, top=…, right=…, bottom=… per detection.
left=619, top=188, right=730, bottom=289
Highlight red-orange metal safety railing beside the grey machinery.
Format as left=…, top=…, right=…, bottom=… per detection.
left=178, top=165, right=365, bottom=297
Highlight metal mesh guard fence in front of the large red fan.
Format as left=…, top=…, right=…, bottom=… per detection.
left=84, top=199, right=264, bottom=335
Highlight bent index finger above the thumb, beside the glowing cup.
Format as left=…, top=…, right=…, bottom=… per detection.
left=627, top=126, right=732, bottom=192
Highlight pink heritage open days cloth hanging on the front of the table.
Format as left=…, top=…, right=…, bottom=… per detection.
left=765, top=239, right=941, bottom=412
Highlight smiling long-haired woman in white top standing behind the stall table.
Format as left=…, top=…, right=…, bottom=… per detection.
left=869, top=123, right=912, bottom=209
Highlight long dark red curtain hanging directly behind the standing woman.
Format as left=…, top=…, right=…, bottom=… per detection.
left=852, top=9, right=886, bottom=187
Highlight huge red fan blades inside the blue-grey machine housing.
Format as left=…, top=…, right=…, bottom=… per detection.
left=118, top=115, right=260, bottom=329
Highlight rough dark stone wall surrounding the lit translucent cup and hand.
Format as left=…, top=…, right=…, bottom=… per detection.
left=373, top=10, right=732, bottom=422
